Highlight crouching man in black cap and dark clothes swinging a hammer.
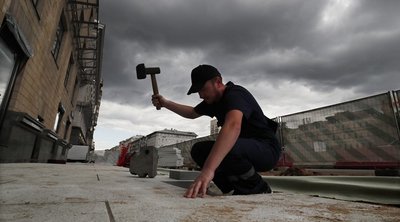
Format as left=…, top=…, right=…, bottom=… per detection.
left=152, top=65, right=281, bottom=198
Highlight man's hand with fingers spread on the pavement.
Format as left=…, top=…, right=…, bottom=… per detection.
left=184, top=171, right=214, bottom=198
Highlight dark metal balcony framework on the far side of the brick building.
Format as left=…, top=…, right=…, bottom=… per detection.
left=68, top=0, right=105, bottom=145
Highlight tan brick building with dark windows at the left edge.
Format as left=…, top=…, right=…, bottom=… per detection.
left=0, top=0, right=105, bottom=162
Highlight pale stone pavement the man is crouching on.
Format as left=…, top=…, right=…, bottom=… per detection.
left=0, top=163, right=400, bottom=222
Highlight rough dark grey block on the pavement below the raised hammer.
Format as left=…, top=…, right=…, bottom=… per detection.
left=129, top=146, right=158, bottom=178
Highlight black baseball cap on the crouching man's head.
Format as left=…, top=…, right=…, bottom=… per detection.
left=187, top=64, right=221, bottom=95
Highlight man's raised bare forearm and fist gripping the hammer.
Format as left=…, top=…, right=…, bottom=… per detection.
left=152, top=95, right=200, bottom=119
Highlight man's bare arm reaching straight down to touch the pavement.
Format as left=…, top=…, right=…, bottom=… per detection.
left=184, top=110, right=243, bottom=198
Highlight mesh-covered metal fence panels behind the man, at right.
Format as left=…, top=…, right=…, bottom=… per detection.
left=275, top=90, right=400, bottom=168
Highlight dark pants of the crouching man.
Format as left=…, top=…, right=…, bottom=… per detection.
left=191, top=138, right=281, bottom=193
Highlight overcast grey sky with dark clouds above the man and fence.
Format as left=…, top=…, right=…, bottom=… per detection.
left=94, top=0, right=400, bottom=150
